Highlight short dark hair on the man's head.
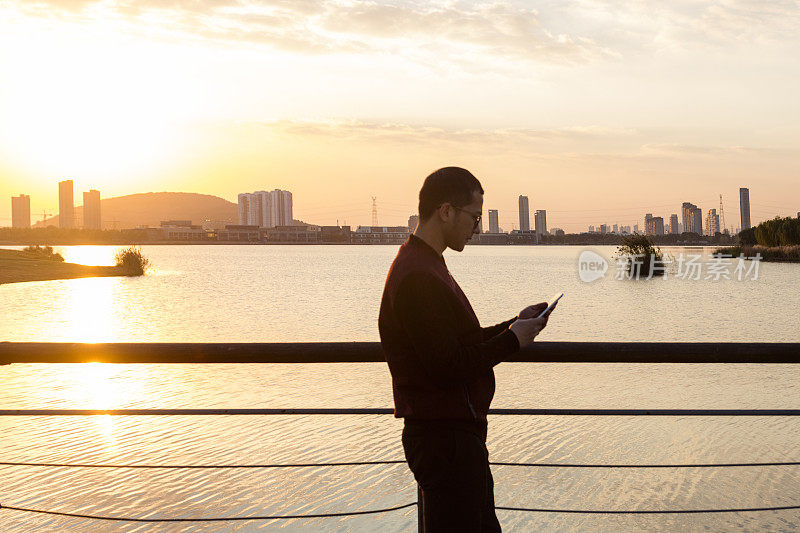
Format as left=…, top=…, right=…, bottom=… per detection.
left=419, top=167, right=483, bottom=220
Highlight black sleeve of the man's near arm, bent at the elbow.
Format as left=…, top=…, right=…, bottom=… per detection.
left=394, top=272, right=519, bottom=387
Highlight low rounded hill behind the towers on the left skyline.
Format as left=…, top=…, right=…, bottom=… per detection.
left=34, top=192, right=239, bottom=229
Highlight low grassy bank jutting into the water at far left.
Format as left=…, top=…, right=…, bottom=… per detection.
left=0, top=249, right=144, bottom=284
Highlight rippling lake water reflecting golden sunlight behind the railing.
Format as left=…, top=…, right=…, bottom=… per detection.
left=0, top=246, right=800, bottom=531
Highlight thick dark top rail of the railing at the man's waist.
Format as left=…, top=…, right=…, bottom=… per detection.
left=0, top=342, right=800, bottom=364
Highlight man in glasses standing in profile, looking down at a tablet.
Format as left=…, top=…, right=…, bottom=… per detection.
left=378, top=167, right=547, bottom=533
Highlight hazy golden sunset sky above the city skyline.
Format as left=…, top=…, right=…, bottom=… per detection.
left=0, top=0, right=800, bottom=231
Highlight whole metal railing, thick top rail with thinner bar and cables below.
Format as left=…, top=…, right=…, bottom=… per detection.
left=0, top=342, right=800, bottom=530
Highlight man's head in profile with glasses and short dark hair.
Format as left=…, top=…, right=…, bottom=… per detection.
left=419, top=167, right=483, bottom=252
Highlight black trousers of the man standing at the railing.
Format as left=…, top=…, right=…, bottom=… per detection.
left=403, top=421, right=501, bottom=533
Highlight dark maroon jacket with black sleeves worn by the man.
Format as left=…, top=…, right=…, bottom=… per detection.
left=378, top=235, right=519, bottom=427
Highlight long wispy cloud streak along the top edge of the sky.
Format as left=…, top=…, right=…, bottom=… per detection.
left=4, top=0, right=614, bottom=64
